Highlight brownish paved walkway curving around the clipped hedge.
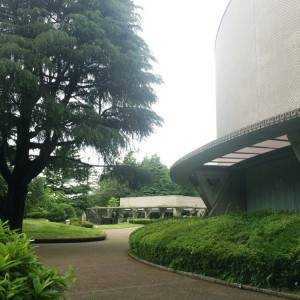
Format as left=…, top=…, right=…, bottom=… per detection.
left=37, top=228, right=283, bottom=300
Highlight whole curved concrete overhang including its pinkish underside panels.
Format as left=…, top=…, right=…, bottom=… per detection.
left=170, top=108, right=300, bottom=187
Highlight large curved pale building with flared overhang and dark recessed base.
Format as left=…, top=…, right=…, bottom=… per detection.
left=171, top=0, right=300, bottom=214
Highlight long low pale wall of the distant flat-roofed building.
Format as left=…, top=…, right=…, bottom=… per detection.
left=120, top=195, right=205, bottom=208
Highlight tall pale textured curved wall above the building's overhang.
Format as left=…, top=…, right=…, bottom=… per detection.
left=215, top=0, right=300, bottom=137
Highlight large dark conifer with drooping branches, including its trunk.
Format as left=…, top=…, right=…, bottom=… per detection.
left=0, top=0, right=161, bottom=229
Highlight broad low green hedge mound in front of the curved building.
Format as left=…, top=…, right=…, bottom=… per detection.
left=130, top=211, right=300, bottom=293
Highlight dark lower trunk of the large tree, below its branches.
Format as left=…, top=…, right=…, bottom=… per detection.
left=0, top=180, right=28, bottom=232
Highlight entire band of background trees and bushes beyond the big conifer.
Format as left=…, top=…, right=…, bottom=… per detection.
left=0, top=152, right=196, bottom=221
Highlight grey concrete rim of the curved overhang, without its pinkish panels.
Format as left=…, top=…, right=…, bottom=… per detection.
left=170, top=113, right=300, bottom=188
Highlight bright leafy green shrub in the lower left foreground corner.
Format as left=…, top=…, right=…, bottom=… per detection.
left=0, top=221, right=74, bottom=300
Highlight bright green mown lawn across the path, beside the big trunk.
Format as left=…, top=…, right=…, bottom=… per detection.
left=23, top=219, right=141, bottom=239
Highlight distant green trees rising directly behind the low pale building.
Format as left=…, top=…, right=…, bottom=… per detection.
left=94, top=152, right=197, bottom=206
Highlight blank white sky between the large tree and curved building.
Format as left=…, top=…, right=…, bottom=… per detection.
left=134, top=0, right=229, bottom=167
